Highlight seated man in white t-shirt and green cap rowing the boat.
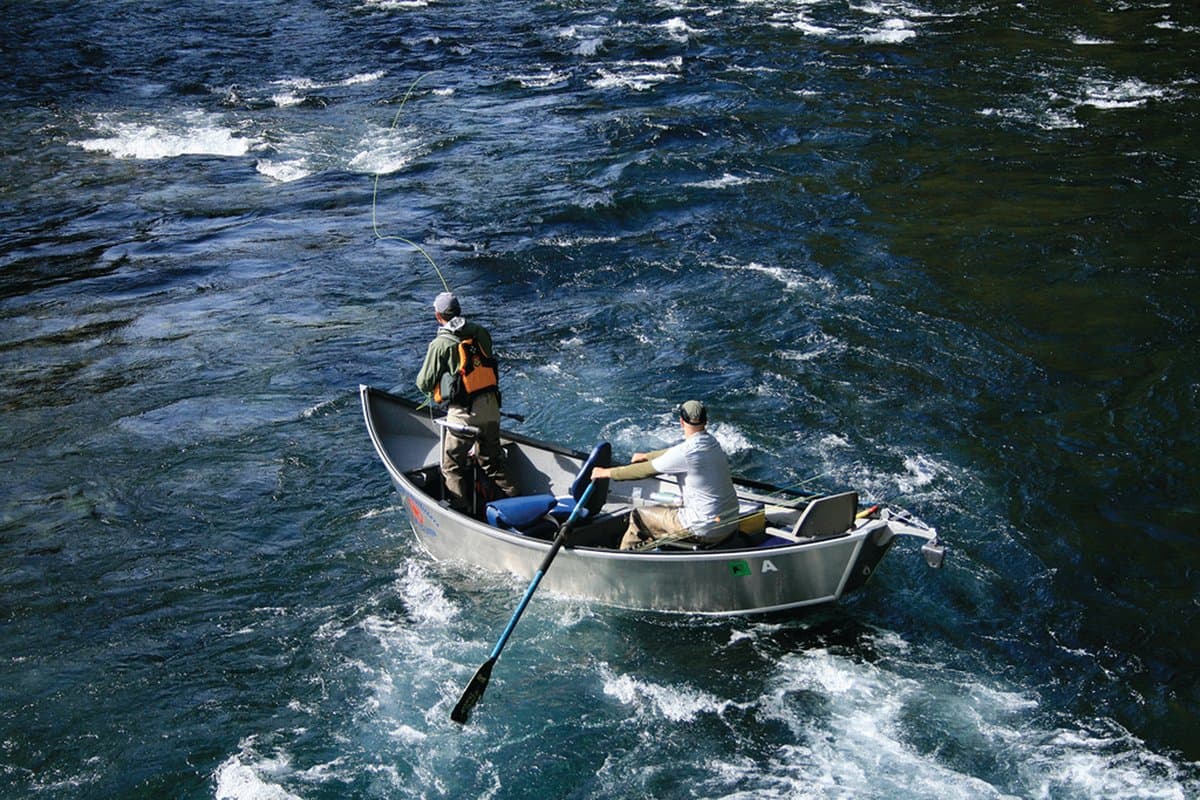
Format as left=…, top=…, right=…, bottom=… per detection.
left=592, top=401, right=738, bottom=551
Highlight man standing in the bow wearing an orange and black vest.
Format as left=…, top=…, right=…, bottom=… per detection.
left=416, top=291, right=516, bottom=513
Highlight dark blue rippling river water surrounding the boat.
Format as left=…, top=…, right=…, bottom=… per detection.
left=0, top=0, right=1200, bottom=800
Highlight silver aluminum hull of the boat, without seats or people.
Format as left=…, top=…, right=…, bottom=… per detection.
left=360, top=386, right=936, bottom=615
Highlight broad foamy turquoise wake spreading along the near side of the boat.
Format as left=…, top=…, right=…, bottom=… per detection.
left=214, top=557, right=1200, bottom=800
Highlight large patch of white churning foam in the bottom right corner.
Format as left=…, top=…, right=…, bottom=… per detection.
left=742, top=632, right=1195, bottom=800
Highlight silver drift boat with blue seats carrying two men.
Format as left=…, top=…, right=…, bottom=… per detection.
left=359, top=386, right=944, bottom=615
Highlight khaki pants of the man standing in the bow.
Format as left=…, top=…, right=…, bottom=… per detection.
left=442, top=392, right=516, bottom=512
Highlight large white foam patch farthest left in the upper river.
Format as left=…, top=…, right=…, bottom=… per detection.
left=72, top=112, right=260, bottom=161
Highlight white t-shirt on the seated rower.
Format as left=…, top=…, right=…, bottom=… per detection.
left=650, top=431, right=738, bottom=539
